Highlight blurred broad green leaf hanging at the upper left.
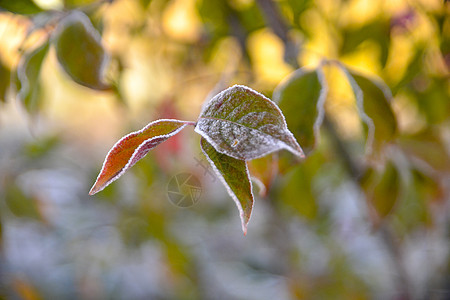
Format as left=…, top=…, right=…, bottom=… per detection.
left=53, top=11, right=110, bottom=90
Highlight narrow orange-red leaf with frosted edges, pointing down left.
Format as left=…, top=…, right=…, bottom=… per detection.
left=89, top=119, right=188, bottom=195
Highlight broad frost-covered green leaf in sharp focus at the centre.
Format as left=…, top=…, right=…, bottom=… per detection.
left=195, top=85, right=304, bottom=160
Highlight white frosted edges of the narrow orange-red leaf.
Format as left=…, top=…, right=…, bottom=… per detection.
left=89, top=119, right=190, bottom=195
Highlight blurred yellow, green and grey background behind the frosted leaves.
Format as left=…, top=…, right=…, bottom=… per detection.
left=0, top=0, right=450, bottom=299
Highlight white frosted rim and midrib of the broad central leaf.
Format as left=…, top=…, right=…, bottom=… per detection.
left=194, top=84, right=305, bottom=160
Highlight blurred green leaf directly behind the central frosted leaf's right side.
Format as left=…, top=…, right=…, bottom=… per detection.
left=273, top=68, right=327, bottom=154
